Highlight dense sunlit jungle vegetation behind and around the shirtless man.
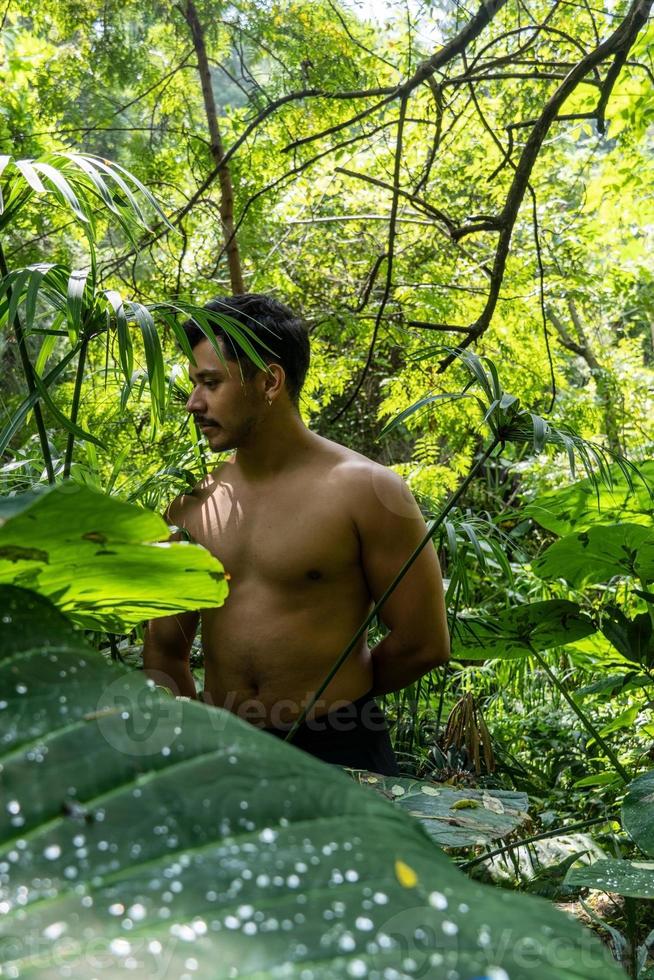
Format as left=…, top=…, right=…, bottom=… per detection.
left=0, top=0, right=654, bottom=978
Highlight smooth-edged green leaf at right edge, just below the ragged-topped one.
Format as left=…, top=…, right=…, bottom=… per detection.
left=532, top=524, right=654, bottom=589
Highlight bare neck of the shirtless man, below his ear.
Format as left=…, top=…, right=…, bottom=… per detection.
left=235, top=406, right=316, bottom=481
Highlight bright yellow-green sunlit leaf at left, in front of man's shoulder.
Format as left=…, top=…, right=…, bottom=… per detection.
left=0, top=483, right=228, bottom=631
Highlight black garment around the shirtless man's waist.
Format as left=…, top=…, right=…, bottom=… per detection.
left=263, top=694, right=400, bottom=776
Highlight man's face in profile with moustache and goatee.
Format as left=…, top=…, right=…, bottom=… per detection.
left=186, top=340, right=265, bottom=452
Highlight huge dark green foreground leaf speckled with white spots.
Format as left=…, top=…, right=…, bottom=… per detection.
left=0, top=595, right=622, bottom=980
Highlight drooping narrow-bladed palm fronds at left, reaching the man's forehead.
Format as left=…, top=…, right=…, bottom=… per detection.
left=0, top=153, right=272, bottom=483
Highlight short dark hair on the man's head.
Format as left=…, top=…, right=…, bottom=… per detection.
left=184, top=293, right=310, bottom=404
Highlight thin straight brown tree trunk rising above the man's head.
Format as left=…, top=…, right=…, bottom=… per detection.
left=179, top=0, right=245, bottom=294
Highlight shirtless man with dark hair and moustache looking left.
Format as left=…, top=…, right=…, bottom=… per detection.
left=144, top=294, right=449, bottom=773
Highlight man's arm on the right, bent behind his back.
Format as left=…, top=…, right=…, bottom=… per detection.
left=356, top=464, right=450, bottom=694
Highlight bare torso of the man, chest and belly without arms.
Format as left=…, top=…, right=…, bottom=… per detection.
left=177, top=440, right=372, bottom=726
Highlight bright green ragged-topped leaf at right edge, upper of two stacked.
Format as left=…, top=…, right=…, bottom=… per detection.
left=524, top=460, right=654, bottom=535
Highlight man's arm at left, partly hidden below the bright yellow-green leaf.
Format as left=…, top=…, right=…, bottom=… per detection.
left=143, top=612, right=200, bottom=698
